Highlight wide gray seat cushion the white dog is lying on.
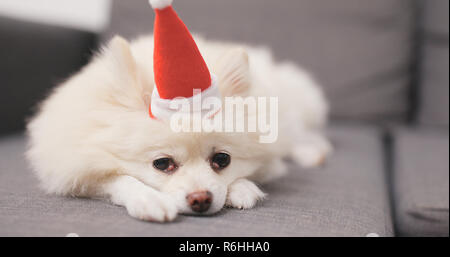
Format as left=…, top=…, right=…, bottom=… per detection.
left=0, top=126, right=393, bottom=236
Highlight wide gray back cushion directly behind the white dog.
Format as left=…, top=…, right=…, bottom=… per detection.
left=104, top=0, right=414, bottom=122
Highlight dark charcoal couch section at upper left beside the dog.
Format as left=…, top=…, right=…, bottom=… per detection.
left=0, top=17, right=97, bottom=136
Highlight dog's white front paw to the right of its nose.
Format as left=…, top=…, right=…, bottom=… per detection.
left=225, top=178, right=266, bottom=209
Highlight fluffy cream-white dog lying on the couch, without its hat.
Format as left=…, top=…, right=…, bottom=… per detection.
left=27, top=36, right=331, bottom=221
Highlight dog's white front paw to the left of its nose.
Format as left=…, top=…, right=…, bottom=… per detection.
left=125, top=187, right=178, bottom=222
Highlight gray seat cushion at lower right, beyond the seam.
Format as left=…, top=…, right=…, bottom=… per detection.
left=394, top=129, right=449, bottom=236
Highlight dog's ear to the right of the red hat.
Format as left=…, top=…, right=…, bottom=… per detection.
left=215, top=47, right=251, bottom=96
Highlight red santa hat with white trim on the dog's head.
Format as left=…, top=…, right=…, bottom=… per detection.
left=149, top=0, right=219, bottom=120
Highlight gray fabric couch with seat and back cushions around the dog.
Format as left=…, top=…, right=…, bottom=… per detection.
left=0, top=0, right=449, bottom=236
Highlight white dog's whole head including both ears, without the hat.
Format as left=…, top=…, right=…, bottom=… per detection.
left=93, top=35, right=273, bottom=214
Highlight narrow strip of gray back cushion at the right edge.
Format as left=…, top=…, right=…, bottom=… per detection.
left=419, top=0, right=449, bottom=126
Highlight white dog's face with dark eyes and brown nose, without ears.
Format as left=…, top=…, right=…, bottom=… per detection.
left=125, top=128, right=267, bottom=214
